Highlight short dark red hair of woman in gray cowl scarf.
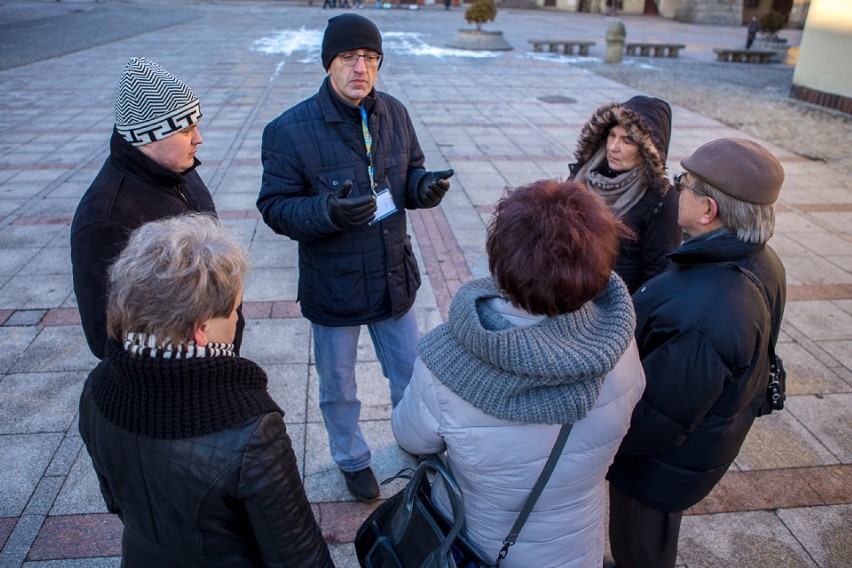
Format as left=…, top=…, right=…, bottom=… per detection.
left=485, top=180, right=624, bottom=317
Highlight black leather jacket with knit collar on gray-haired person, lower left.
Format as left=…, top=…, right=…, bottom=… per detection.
left=80, top=341, right=333, bottom=568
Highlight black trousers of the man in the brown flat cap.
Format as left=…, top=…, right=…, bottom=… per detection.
left=609, top=484, right=683, bottom=568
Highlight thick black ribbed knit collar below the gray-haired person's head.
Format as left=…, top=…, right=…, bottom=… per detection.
left=88, top=341, right=284, bottom=440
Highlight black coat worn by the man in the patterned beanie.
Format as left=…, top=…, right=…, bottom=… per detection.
left=71, top=130, right=236, bottom=359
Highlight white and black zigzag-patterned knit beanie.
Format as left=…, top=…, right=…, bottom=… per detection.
left=115, top=57, right=201, bottom=146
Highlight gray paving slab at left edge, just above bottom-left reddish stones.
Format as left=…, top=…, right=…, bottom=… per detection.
left=0, top=434, right=63, bottom=516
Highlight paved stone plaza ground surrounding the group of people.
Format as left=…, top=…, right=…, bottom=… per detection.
left=0, top=1, right=852, bottom=568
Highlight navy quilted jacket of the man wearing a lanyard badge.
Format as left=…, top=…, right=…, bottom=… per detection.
left=257, top=78, right=425, bottom=326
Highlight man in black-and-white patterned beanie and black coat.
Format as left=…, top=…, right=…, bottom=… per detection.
left=71, top=57, right=244, bottom=359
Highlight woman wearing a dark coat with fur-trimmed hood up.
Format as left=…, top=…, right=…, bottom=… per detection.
left=569, top=96, right=683, bottom=294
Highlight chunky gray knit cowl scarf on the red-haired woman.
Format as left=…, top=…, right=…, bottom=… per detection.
left=417, top=273, right=636, bottom=424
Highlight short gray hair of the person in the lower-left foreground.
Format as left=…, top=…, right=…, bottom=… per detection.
left=107, top=213, right=249, bottom=343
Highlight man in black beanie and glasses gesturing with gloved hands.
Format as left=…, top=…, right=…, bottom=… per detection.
left=257, top=13, right=453, bottom=501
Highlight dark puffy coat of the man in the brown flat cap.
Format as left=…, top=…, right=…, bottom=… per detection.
left=607, top=229, right=786, bottom=511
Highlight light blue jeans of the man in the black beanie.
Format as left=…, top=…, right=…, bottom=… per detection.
left=311, top=307, right=420, bottom=472
